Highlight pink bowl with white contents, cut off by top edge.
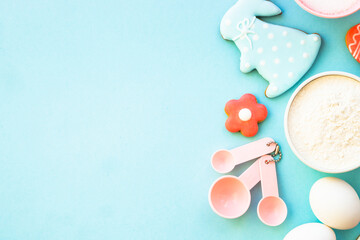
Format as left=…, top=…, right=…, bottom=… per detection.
left=295, top=0, right=360, bottom=18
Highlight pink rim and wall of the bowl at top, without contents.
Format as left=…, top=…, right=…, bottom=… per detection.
left=295, top=0, right=360, bottom=18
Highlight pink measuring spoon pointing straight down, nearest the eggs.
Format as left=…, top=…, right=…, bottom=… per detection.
left=257, top=155, right=287, bottom=226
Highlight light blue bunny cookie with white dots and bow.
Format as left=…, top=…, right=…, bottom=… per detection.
left=220, top=0, right=321, bottom=98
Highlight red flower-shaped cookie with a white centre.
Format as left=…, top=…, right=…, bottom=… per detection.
left=225, top=93, right=267, bottom=137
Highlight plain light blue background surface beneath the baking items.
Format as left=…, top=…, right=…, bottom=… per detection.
left=0, top=0, right=360, bottom=240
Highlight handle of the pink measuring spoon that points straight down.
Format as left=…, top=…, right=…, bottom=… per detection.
left=258, top=155, right=279, bottom=198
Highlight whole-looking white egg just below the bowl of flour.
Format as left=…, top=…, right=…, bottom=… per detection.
left=310, top=177, right=360, bottom=230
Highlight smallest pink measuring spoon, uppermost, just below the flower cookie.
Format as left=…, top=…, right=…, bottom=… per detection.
left=211, top=138, right=277, bottom=173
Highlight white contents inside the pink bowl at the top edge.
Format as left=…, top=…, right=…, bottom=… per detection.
left=302, top=0, right=358, bottom=13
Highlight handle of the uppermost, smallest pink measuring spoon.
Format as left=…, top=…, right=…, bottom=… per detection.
left=230, top=138, right=276, bottom=165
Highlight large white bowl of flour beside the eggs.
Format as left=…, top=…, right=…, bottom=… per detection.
left=284, top=72, right=360, bottom=173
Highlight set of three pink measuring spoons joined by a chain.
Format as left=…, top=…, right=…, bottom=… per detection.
left=209, top=138, right=287, bottom=226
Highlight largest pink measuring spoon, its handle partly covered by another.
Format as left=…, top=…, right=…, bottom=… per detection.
left=209, top=160, right=260, bottom=219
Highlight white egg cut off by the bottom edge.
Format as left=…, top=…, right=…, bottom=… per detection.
left=284, top=223, right=336, bottom=240
